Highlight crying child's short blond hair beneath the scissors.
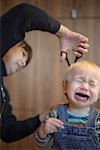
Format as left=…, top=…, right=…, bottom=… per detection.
left=63, top=60, right=100, bottom=82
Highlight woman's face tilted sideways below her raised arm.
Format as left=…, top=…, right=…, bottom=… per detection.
left=3, top=46, right=28, bottom=75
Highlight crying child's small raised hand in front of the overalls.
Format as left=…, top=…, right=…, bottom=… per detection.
left=39, top=117, right=64, bottom=138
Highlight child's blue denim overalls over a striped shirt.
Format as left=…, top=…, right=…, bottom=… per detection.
left=50, top=105, right=100, bottom=150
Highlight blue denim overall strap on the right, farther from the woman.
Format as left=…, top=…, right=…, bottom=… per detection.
left=87, top=108, right=100, bottom=127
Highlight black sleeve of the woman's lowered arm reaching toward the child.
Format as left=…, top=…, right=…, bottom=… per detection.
left=1, top=88, right=40, bottom=143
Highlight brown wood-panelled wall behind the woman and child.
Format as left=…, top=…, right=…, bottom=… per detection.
left=0, top=0, right=100, bottom=150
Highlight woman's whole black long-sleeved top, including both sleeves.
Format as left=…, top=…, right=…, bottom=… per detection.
left=0, top=3, right=60, bottom=142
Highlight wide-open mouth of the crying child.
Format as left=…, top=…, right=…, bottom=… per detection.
left=75, top=93, right=89, bottom=102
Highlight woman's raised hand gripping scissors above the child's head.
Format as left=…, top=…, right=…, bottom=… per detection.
left=56, top=25, right=89, bottom=62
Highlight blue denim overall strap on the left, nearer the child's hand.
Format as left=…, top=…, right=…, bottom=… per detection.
left=57, top=104, right=68, bottom=124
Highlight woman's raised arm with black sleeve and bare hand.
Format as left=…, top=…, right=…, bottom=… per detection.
left=0, top=3, right=89, bottom=60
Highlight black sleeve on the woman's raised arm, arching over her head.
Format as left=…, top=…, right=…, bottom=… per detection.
left=0, top=4, right=60, bottom=56
